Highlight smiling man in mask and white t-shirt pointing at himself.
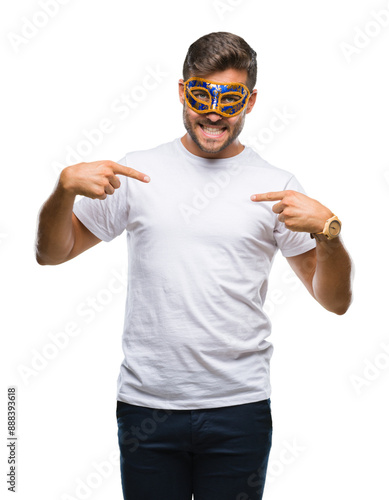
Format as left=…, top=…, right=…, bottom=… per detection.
left=37, top=32, right=352, bottom=500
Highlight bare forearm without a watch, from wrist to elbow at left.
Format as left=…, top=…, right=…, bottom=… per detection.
left=36, top=182, right=75, bottom=265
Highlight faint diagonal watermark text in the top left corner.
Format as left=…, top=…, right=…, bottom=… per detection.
left=7, top=0, right=70, bottom=54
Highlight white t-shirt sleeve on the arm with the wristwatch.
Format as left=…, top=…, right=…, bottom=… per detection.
left=274, top=176, right=316, bottom=257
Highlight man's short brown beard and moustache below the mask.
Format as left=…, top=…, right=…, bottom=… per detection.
left=183, top=103, right=246, bottom=153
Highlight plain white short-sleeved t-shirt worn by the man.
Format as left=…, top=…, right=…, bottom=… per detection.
left=74, top=135, right=316, bottom=409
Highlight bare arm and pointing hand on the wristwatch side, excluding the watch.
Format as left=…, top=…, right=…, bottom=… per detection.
left=250, top=191, right=354, bottom=314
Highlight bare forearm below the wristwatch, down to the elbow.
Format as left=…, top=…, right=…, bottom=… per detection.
left=312, top=237, right=354, bottom=314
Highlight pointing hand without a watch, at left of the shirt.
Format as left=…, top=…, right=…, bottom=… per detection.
left=59, top=160, right=150, bottom=200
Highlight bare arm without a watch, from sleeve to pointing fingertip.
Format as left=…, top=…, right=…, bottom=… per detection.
left=36, top=161, right=149, bottom=265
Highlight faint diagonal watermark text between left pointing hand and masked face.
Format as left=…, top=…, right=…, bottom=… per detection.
left=52, top=65, right=168, bottom=175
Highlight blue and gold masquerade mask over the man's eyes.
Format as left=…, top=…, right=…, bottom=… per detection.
left=184, top=77, right=250, bottom=118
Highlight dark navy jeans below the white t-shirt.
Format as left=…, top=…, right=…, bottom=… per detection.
left=116, top=399, right=272, bottom=500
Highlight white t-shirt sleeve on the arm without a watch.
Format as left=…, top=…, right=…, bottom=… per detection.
left=73, top=157, right=130, bottom=241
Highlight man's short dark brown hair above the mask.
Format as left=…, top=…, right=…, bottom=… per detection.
left=183, top=31, right=257, bottom=92
